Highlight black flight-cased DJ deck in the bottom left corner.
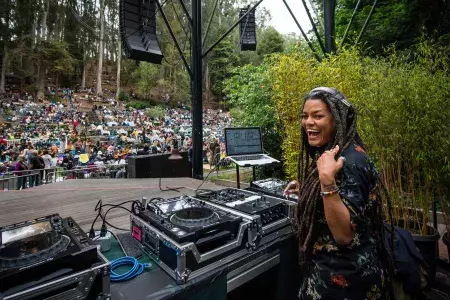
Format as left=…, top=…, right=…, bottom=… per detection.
left=0, top=214, right=109, bottom=300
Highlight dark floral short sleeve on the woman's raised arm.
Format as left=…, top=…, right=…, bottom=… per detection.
left=338, top=159, right=376, bottom=233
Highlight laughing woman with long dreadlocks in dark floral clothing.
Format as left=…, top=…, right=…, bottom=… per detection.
left=285, top=87, right=387, bottom=300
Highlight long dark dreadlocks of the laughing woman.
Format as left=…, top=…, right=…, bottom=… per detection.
left=296, top=88, right=393, bottom=282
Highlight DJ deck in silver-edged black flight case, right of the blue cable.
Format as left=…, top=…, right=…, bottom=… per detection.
left=131, top=196, right=259, bottom=284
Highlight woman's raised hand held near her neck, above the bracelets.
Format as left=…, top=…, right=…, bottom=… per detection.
left=317, top=145, right=345, bottom=186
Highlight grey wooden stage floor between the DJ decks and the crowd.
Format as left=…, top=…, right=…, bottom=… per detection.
left=0, top=178, right=221, bottom=232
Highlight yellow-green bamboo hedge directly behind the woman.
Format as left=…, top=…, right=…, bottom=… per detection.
left=270, top=43, right=450, bottom=229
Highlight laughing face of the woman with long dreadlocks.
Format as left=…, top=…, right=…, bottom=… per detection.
left=302, top=99, right=335, bottom=147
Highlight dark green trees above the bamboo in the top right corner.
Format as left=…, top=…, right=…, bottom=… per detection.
left=324, top=0, right=450, bottom=54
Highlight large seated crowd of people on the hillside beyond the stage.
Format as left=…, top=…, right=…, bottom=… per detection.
left=0, top=90, right=232, bottom=189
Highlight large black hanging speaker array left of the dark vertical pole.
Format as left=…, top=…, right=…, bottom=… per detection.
left=119, top=0, right=163, bottom=64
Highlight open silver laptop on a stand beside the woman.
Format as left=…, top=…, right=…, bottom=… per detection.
left=225, top=127, right=280, bottom=167
